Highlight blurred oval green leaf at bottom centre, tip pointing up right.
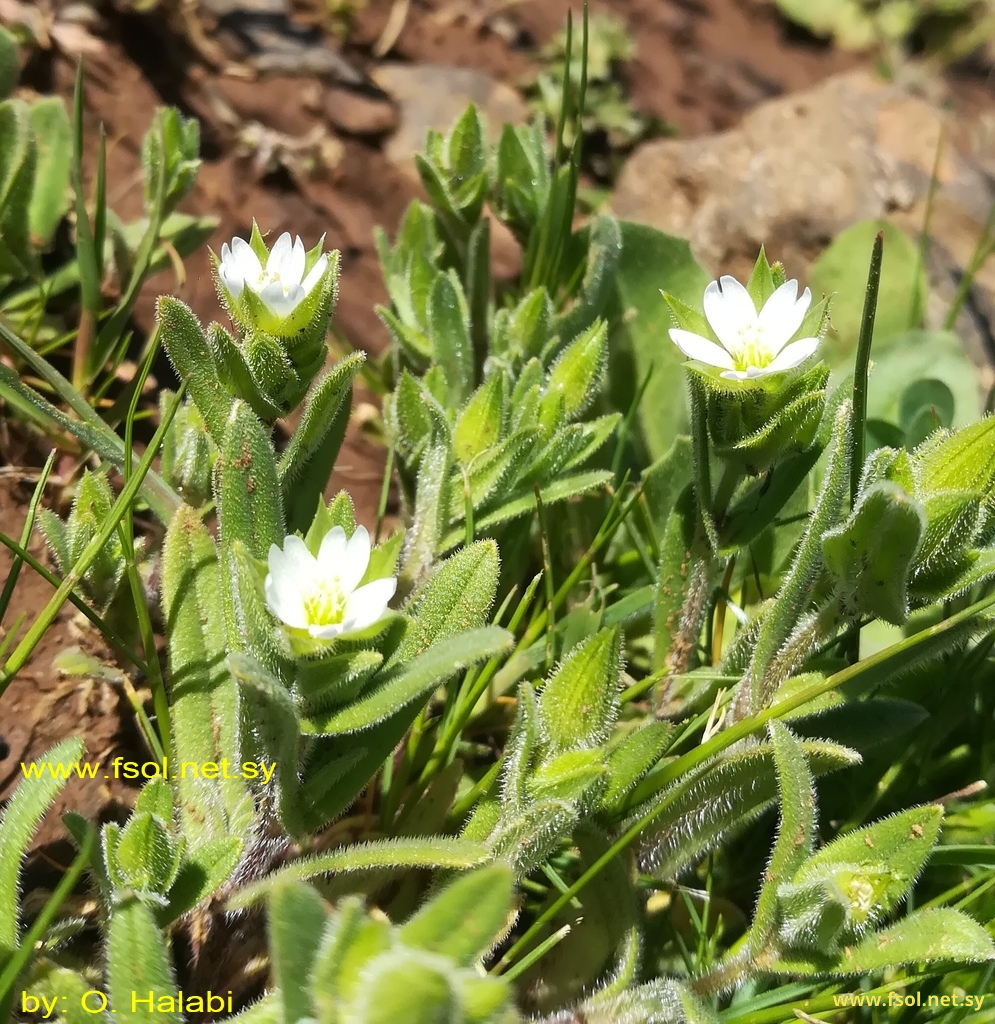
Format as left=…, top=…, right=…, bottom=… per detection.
left=397, top=864, right=514, bottom=967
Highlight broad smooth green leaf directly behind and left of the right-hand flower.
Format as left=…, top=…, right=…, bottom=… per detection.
left=608, top=227, right=708, bottom=463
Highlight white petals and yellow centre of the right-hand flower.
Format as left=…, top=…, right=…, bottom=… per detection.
left=670, top=276, right=819, bottom=380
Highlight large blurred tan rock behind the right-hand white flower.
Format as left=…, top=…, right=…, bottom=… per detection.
left=612, top=71, right=995, bottom=361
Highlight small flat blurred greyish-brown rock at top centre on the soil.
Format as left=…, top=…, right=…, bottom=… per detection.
left=371, top=63, right=528, bottom=174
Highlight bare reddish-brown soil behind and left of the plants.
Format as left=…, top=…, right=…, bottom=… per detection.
left=0, top=0, right=854, bottom=847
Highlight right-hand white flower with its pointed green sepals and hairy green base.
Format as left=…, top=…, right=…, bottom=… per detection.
left=663, top=258, right=829, bottom=475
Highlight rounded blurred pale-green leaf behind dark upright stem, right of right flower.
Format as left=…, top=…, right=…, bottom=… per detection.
left=809, top=220, right=926, bottom=367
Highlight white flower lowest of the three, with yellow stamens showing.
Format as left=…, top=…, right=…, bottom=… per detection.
left=264, top=526, right=397, bottom=640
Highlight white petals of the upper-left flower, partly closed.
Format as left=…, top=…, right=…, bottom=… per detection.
left=218, top=231, right=329, bottom=319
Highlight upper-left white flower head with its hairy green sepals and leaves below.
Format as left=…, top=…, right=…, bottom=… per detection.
left=209, top=221, right=339, bottom=420
